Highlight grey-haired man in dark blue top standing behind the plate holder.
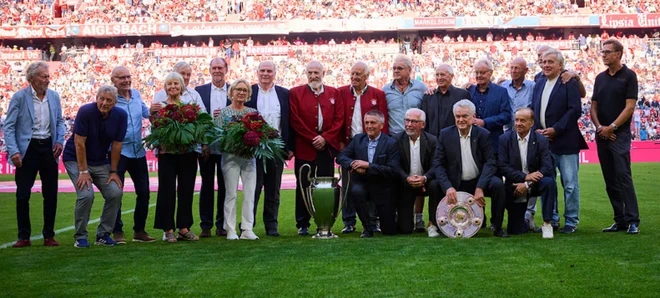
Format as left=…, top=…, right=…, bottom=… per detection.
left=468, top=59, right=512, bottom=157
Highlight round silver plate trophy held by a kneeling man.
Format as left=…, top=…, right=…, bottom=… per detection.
left=436, top=191, right=484, bottom=238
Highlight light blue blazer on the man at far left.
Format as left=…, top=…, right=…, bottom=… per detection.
left=4, top=87, right=65, bottom=165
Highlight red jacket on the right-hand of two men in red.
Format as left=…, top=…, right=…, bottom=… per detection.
left=337, top=85, right=389, bottom=146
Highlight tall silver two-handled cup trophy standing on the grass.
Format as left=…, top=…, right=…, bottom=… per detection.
left=298, top=164, right=350, bottom=239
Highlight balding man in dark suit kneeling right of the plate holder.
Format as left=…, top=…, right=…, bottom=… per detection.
left=497, top=108, right=557, bottom=238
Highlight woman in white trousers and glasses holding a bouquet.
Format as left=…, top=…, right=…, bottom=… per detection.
left=216, top=79, right=259, bottom=240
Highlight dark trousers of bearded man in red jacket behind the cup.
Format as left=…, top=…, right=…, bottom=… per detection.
left=294, top=146, right=336, bottom=228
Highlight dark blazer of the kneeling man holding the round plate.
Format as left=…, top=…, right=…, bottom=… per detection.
left=433, top=125, right=497, bottom=193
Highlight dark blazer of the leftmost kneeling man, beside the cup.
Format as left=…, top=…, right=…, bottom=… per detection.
left=337, top=133, right=401, bottom=184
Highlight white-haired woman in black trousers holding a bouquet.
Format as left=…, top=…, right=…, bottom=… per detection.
left=151, top=72, right=205, bottom=243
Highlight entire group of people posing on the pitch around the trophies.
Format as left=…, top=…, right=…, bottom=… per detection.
left=4, top=39, right=639, bottom=247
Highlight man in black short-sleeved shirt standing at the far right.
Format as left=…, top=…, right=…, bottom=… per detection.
left=591, top=39, right=639, bottom=234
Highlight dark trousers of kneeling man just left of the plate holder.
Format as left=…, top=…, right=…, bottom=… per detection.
left=396, top=180, right=442, bottom=234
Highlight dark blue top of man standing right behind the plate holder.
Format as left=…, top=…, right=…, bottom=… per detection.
left=468, top=82, right=513, bottom=154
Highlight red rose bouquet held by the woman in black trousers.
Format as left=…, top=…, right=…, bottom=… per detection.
left=143, top=103, right=220, bottom=152
